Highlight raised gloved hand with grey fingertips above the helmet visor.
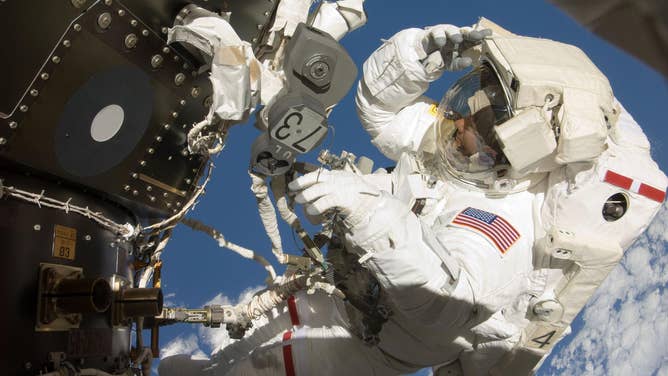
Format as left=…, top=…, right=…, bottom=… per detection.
left=422, top=24, right=492, bottom=72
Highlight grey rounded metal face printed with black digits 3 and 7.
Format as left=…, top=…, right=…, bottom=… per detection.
left=270, top=106, right=327, bottom=153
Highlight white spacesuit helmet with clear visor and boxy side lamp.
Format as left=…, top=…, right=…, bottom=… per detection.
left=423, top=27, right=618, bottom=194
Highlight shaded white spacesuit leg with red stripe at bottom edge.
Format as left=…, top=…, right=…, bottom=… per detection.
left=209, top=292, right=399, bottom=376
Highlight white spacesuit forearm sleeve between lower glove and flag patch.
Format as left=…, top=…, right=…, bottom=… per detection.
left=346, top=194, right=474, bottom=325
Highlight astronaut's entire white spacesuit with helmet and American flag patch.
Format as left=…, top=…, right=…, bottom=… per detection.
left=159, top=19, right=667, bottom=375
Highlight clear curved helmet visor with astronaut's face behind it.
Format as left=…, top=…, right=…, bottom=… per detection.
left=436, top=63, right=511, bottom=174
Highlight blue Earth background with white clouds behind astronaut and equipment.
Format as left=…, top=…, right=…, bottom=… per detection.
left=153, top=0, right=668, bottom=376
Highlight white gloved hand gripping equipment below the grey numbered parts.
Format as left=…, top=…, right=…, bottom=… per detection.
left=288, top=169, right=382, bottom=229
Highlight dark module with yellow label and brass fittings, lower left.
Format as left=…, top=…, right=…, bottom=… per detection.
left=0, top=169, right=134, bottom=375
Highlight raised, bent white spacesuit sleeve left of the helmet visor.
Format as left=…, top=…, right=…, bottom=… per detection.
left=356, top=29, right=443, bottom=160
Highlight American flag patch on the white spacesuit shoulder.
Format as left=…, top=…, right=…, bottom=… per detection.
left=452, top=207, right=520, bottom=254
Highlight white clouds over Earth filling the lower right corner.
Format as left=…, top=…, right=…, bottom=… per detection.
left=541, top=205, right=668, bottom=376
